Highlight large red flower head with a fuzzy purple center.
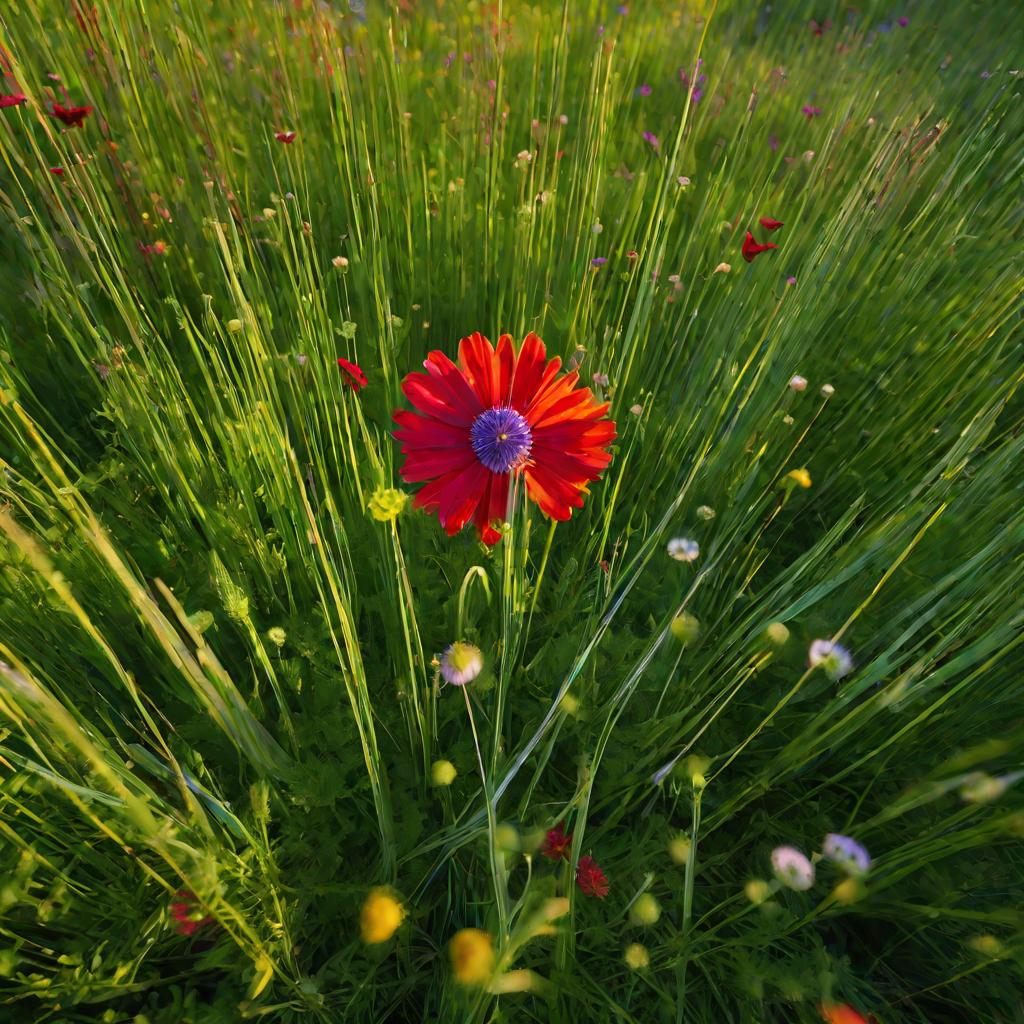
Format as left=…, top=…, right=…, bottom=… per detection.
left=394, top=332, right=615, bottom=544
